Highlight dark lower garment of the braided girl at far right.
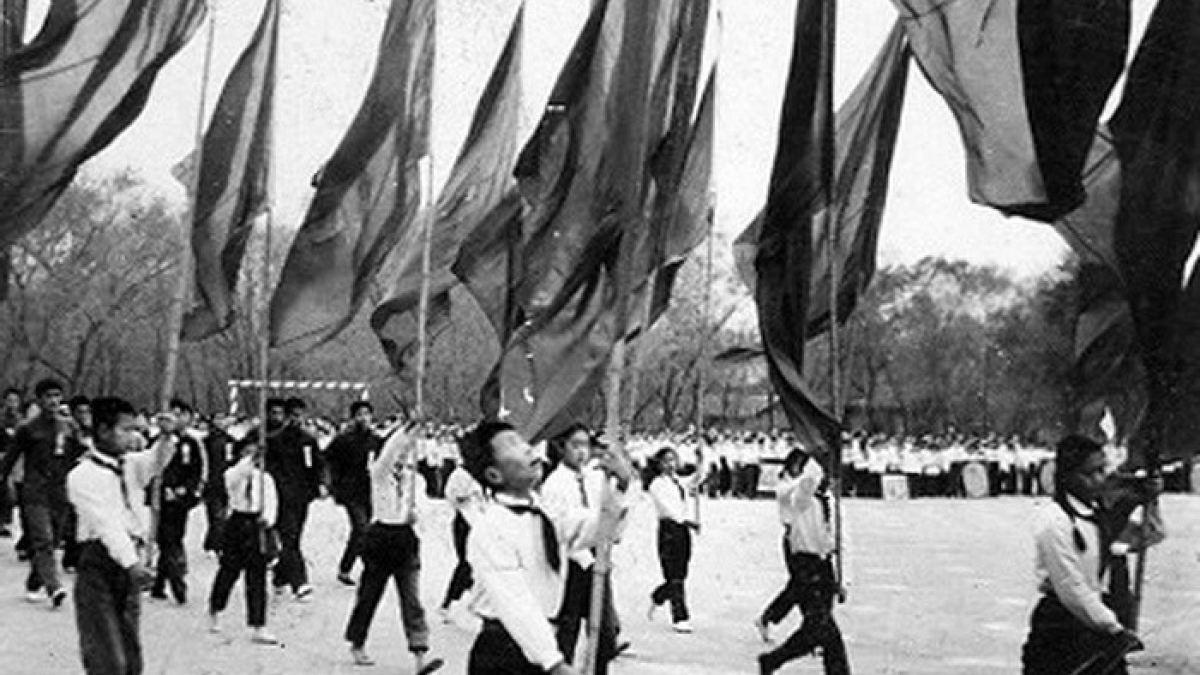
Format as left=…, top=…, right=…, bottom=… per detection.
left=1021, top=596, right=1128, bottom=675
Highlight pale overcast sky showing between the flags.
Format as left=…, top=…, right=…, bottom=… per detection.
left=35, top=0, right=1153, bottom=274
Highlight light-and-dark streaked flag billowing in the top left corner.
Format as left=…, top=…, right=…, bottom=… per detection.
left=0, top=0, right=206, bottom=296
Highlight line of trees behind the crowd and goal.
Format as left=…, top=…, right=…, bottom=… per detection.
left=0, top=172, right=1099, bottom=435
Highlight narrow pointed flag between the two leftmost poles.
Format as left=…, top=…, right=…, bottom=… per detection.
left=182, top=0, right=280, bottom=340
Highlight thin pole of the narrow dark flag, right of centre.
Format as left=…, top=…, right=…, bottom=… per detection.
left=821, top=0, right=846, bottom=586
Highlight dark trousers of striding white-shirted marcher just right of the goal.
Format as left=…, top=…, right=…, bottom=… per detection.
left=346, top=522, right=430, bottom=653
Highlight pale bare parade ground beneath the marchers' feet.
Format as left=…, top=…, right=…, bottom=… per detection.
left=0, top=495, right=1200, bottom=675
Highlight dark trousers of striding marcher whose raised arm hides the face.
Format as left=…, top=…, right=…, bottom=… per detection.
left=762, top=540, right=850, bottom=675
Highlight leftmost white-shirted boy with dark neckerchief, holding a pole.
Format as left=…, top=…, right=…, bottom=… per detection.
left=67, top=398, right=150, bottom=675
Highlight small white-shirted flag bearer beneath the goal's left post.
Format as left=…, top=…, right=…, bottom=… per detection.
left=209, top=435, right=278, bottom=645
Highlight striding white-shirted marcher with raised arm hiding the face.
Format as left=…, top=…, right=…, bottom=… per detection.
left=755, top=448, right=850, bottom=675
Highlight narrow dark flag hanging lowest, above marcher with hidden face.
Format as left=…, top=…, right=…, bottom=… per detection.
left=755, top=0, right=839, bottom=455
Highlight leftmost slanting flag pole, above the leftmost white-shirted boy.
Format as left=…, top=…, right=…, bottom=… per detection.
left=158, top=10, right=217, bottom=410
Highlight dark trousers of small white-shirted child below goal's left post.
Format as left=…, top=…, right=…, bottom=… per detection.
left=209, top=513, right=266, bottom=628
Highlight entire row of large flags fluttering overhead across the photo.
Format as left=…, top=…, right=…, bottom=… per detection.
left=7, top=0, right=1200, bottom=454
